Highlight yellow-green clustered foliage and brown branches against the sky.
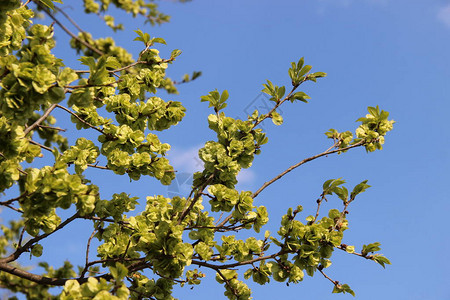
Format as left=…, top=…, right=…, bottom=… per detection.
left=0, top=0, right=393, bottom=299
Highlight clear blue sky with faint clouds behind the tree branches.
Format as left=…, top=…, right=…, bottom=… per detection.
left=1, top=0, right=450, bottom=299
